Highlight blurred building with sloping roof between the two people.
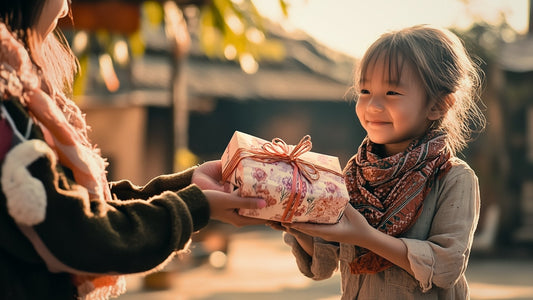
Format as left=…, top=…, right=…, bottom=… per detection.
left=61, top=1, right=363, bottom=184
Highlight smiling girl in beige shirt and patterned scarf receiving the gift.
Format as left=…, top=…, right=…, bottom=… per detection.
left=272, top=26, right=484, bottom=299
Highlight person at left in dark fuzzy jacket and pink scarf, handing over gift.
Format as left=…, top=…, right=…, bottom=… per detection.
left=0, top=0, right=265, bottom=300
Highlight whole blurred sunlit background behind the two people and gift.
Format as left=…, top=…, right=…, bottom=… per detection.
left=56, top=0, right=533, bottom=300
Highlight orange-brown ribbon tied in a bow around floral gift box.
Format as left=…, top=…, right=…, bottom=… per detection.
left=222, top=135, right=342, bottom=222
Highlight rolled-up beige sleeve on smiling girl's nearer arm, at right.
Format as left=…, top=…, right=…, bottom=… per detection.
left=402, top=165, right=480, bottom=291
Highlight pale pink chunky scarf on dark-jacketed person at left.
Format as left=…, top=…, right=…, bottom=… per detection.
left=0, top=23, right=121, bottom=300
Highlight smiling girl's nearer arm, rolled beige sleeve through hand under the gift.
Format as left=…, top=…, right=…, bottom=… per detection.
left=287, top=161, right=480, bottom=291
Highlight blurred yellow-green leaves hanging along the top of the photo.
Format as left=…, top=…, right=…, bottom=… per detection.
left=70, top=0, right=289, bottom=95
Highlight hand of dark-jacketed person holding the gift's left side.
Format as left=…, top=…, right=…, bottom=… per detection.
left=203, top=190, right=266, bottom=227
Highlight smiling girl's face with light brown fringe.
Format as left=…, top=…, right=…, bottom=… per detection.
left=355, top=61, right=440, bottom=156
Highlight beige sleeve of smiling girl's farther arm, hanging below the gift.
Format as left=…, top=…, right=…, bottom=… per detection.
left=283, top=233, right=339, bottom=280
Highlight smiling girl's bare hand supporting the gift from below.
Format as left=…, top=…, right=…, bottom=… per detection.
left=284, top=205, right=374, bottom=245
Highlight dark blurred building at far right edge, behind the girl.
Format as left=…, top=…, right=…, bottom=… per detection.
left=500, top=32, right=533, bottom=245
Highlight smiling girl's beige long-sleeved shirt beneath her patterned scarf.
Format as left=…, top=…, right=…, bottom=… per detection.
left=284, top=158, right=480, bottom=300
